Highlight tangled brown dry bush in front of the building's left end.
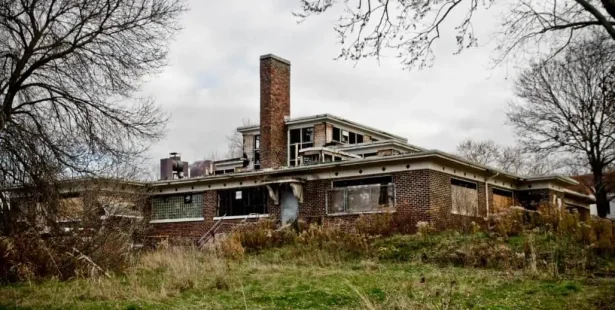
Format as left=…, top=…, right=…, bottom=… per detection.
left=0, top=179, right=148, bottom=282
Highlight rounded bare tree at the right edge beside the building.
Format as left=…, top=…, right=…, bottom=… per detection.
left=508, top=36, right=615, bottom=217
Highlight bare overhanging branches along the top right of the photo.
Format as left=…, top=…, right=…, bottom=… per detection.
left=295, top=0, right=615, bottom=69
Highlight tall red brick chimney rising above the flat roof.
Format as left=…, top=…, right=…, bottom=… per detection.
left=260, top=54, right=290, bottom=168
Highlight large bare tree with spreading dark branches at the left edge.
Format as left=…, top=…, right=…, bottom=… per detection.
left=0, top=0, right=184, bottom=231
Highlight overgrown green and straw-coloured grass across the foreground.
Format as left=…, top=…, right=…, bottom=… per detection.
left=0, top=231, right=615, bottom=309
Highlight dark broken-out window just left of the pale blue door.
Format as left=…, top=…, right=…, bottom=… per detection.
left=217, top=186, right=268, bottom=216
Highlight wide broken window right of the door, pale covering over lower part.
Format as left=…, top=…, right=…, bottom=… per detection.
left=327, top=176, right=395, bottom=214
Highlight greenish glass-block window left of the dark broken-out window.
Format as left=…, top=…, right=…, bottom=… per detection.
left=151, top=194, right=203, bottom=221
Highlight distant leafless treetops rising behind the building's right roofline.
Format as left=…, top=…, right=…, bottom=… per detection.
left=456, top=139, right=561, bottom=176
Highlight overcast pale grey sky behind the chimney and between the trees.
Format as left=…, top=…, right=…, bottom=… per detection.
left=143, top=0, right=514, bottom=162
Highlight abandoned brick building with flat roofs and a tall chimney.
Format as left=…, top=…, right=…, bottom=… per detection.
left=150, top=55, right=591, bottom=237
